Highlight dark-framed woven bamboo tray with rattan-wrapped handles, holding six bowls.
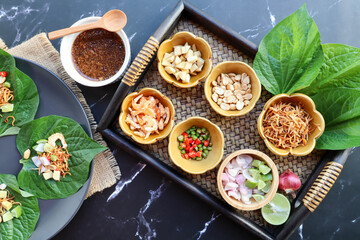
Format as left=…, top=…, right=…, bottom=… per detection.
left=98, top=1, right=350, bottom=239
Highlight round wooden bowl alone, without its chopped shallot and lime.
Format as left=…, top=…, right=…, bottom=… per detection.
left=217, top=149, right=279, bottom=211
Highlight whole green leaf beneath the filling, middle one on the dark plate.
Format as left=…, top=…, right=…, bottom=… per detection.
left=16, top=115, right=106, bottom=199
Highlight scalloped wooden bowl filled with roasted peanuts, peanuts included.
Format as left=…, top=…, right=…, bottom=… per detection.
left=204, top=61, right=261, bottom=116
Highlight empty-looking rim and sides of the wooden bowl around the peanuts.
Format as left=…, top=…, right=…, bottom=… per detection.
left=204, top=61, right=261, bottom=117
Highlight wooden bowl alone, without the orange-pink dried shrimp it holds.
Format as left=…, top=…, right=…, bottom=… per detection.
left=119, top=88, right=175, bottom=144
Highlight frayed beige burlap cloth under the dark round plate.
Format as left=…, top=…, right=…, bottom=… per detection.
left=0, top=33, right=121, bottom=198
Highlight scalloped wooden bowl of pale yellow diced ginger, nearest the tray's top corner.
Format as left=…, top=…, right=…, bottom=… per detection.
left=157, top=32, right=212, bottom=88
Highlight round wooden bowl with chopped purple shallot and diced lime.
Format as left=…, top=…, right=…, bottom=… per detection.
left=217, top=149, right=279, bottom=211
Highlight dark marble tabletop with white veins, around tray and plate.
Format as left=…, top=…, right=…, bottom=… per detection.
left=0, top=0, right=360, bottom=240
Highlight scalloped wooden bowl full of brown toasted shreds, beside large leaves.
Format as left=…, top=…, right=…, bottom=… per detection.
left=257, top=93, right=325, bottom=156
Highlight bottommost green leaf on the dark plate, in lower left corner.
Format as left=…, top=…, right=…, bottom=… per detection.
left=0, top=174, right=40, bottom=240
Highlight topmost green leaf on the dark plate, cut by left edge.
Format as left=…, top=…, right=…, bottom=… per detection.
left=0, top=49, right=39, bottom=137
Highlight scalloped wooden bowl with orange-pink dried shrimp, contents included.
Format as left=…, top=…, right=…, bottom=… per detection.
left=119, top=88, right=175, bottom=144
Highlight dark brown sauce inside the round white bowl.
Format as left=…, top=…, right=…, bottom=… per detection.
left=71, top=28, right=125, bottom=81
